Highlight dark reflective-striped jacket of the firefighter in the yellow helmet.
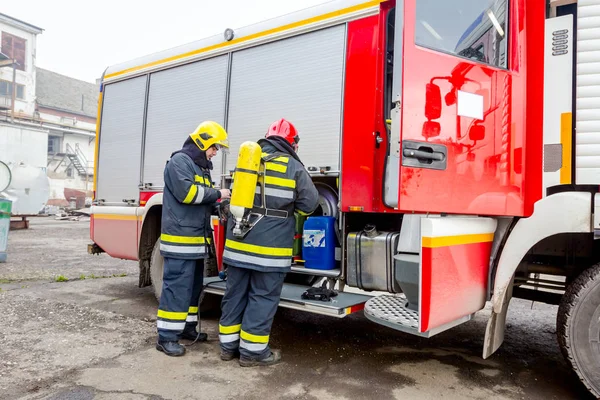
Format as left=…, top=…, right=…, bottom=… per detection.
left=160, top=152, right=220, bottom=260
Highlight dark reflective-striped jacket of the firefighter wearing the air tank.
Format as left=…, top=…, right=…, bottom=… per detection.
left=223, top=141, right=319, bottom=272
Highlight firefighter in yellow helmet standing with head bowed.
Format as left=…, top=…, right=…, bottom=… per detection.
left=156, top=121, right=230, bottom=356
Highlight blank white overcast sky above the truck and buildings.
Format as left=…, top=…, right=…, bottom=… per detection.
left=0, top=0, right=328, bottom=82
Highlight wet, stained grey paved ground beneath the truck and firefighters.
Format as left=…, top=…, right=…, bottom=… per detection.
left=0, top=219, right=591, bottom=400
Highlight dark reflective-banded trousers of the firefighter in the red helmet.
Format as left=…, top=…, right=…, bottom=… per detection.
left=219, top=266, right=286, bottom=360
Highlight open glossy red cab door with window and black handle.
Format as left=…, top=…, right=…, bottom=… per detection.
left=398, top=0, right=512, bottom=215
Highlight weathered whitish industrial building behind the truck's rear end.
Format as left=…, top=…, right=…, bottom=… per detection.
left=0, top=13, right=99, bottom=216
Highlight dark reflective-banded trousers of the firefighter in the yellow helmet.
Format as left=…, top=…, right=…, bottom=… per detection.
left=156, top=257, right=204, bottom=342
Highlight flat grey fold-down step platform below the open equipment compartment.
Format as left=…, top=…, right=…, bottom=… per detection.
left=204, top=276, right=372, bottom=318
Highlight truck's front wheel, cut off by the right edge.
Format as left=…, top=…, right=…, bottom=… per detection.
left=557, top=264, right=600, bottom=397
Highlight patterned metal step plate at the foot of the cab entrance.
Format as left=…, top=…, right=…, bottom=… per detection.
left=364, top=294, right=471, bottom=337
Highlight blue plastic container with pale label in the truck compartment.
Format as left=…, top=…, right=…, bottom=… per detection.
left=302, top=217, right=336, bottom=270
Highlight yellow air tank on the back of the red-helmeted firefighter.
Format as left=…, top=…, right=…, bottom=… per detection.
left=229, top=142, right=262, bottom=231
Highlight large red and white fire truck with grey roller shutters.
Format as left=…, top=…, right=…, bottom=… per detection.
left=89, top=0, right=600, bottom=395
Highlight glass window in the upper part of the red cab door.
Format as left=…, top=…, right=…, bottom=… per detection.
left=415, top=0, right=508, bottom=68
